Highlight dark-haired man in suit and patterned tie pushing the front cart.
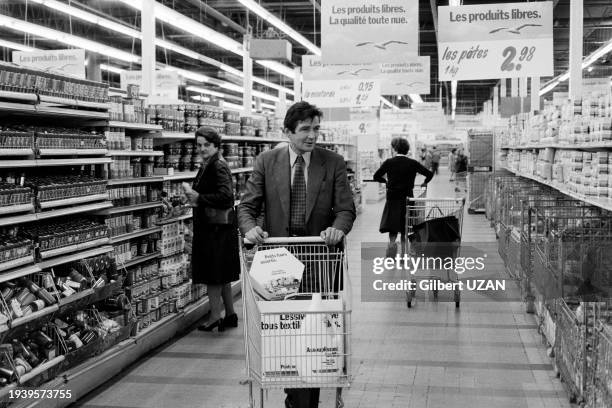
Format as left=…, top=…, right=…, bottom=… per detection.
left=238, top=102, right=356, bottom=408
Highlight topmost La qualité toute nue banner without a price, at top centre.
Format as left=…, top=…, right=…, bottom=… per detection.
left=321, top=0, right=419, bottom=64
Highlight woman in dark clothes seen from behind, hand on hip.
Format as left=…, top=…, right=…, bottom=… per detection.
left=374, top=137, right=433, bottom=257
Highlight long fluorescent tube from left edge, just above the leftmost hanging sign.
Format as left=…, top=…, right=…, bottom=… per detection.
left=0, top=14, right=140, bottom=62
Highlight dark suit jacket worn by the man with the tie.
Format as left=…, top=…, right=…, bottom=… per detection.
left=238, top=147, right=356, bottom=237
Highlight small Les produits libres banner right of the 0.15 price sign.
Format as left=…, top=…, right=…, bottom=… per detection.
left=380, top=56, right=431, bottom=95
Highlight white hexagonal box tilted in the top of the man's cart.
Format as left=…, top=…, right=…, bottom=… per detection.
left=249, top=247, right=304, bottom=300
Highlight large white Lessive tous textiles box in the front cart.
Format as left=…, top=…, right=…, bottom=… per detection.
left=258, top=293, right=346, bottom=384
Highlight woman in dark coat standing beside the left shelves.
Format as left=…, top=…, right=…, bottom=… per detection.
left=183, top=127, right=240, bottom=332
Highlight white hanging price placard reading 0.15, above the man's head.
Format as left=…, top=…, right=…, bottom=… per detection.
left=302, top=79, right=380, bottom=108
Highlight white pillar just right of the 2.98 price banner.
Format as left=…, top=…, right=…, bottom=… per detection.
left=569, top=0, right=584, bottom=100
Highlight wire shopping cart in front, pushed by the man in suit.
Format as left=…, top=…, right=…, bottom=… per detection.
left=240, top=237, right=351, bottom=408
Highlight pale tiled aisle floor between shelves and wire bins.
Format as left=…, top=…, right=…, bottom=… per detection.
left=78, top=170, right=570, bottom=408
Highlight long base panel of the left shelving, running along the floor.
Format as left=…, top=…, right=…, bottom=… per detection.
left=11, top=281, right=240, bottom=408
